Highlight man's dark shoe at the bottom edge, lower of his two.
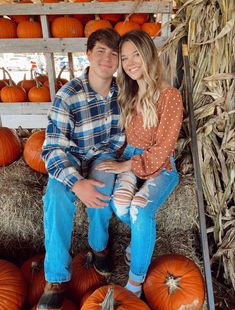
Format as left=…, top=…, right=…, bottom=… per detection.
left=37, top=282, right=68, bottom=310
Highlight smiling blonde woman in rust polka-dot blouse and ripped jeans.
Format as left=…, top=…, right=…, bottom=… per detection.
left=98, top=30, right=183, bottom=296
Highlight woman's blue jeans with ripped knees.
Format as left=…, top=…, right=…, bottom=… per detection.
left=111, top=145, right=179, bottom=283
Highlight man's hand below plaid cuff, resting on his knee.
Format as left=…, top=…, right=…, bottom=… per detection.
left=72, top=179, right=110, bottom=208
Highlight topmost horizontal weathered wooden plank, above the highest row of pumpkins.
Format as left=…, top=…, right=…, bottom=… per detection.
left=0, top=1, right=172, bottom=15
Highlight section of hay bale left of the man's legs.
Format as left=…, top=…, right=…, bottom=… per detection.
left=0, top=158, right=47, bottom=263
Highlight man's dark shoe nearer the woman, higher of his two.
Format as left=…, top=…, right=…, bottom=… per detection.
left=93, top=248, right=112, bottom=277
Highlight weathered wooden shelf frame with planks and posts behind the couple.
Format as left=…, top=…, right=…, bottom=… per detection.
left=0, top=0, right=172, bottom=128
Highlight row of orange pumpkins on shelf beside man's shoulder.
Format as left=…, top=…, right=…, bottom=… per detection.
left=0, top=67, right=68, bottom=102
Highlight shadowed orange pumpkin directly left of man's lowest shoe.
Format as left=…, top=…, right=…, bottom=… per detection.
left=20, top=255, right=46, bottom=307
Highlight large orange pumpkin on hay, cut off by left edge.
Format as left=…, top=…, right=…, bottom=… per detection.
left=0, top=127, right=21, bottom=167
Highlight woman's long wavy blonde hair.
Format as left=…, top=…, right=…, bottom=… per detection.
left=117, top=30, right=163, bottom=128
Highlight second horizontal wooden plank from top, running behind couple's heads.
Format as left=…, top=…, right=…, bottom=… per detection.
left=0, top=37, right=167, bottom=53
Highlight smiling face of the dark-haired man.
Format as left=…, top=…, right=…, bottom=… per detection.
left=87, top=42, right=118, bottom=80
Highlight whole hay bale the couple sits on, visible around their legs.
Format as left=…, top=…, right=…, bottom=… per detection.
left=0, top=159, right=201, bottom=278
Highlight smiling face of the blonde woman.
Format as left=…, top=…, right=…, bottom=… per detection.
left=121, top=41, right=143, bottom=81
